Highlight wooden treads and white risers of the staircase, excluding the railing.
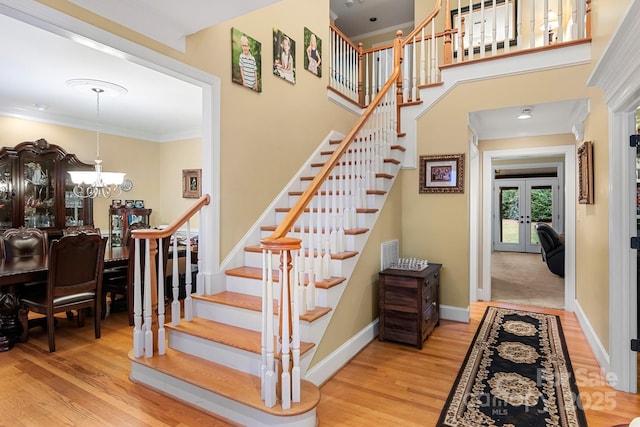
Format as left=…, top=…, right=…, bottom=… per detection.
left=130, top=133, right=404, bottom=426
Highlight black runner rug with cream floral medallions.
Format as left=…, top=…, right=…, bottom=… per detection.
left=437, top=307, right=587, bottom=427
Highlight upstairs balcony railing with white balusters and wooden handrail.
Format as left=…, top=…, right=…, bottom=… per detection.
left=329, top=0, right=591, bottom=107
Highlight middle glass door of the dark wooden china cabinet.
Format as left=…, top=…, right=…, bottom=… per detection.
left=23, top=158, right=56, bottom=228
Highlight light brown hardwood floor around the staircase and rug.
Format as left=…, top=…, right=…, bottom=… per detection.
left=0, top=303, right=640, bottom=427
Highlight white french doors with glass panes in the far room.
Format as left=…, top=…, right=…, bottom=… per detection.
left=493, top=178, right=558, bottom=252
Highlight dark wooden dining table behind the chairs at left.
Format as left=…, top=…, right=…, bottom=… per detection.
left=0, top=246, right=129, bottom=352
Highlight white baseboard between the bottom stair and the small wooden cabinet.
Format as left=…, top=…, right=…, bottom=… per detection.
left=305, top=319, right=378, bottom=387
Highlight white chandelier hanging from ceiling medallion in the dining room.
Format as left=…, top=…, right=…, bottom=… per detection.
left=67, top=79, right=127, bottom=199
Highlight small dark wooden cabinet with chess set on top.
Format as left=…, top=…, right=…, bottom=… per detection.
left=378, top=264, right=442, bottom=349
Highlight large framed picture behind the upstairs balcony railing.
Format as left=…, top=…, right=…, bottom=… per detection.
left=451, top=0, right=516, bottom=55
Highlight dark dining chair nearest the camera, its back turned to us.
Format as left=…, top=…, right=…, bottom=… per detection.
left=20, top=233, right=107, bottom=352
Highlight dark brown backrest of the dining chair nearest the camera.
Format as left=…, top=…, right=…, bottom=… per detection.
left=48, top=233, right=107, bottom=298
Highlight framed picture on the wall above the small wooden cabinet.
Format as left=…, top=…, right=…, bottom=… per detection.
left=419, top=154, right=464, bottom=193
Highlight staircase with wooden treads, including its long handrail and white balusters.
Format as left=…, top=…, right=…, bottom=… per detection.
left=130, top=2, right=596, bottom=427
